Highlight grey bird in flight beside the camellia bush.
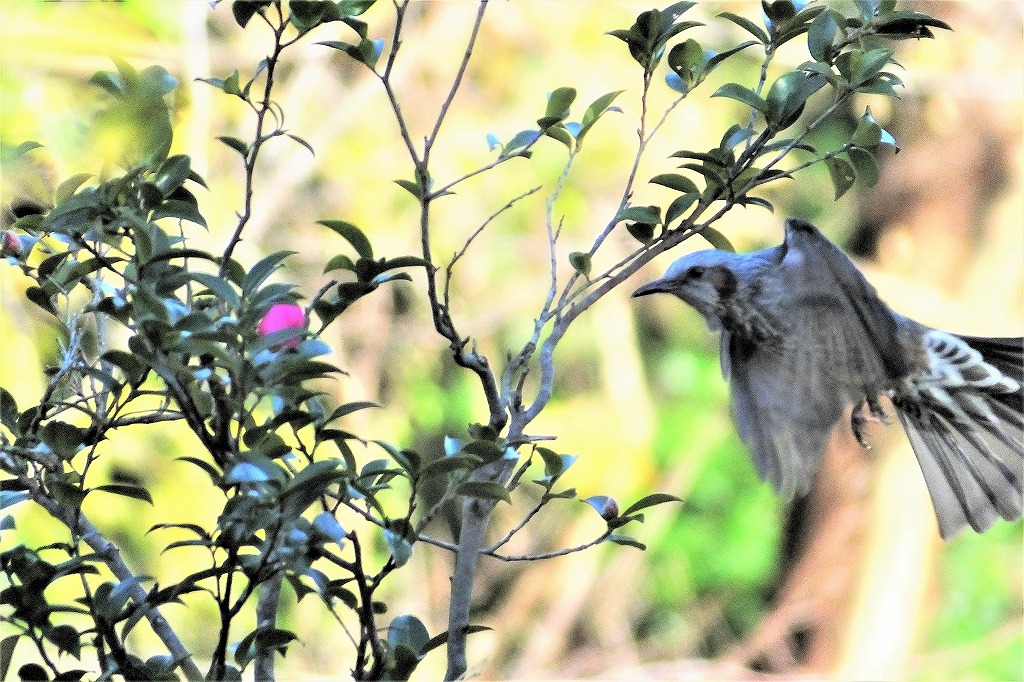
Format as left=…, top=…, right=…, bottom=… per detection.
left=633, top=218, right=1024, bottom=539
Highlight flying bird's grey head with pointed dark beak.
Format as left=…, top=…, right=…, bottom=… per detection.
left=633, top=249, right=739, bottom=329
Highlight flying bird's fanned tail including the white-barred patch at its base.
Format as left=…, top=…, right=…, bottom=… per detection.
left=893, top=330, right=1024, bottom=539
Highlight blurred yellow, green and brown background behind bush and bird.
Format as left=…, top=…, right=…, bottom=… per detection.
left=0, top=0, right=1024, bottom=680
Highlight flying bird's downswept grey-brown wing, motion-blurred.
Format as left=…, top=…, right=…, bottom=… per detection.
left=725, top=219, right=911, bottom=497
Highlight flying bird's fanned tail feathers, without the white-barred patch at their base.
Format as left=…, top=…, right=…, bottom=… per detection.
left=893, top=337, right=1024, bottom=538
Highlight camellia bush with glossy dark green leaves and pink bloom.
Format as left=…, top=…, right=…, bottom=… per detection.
left=0, top=0, right=948, bottom=680
